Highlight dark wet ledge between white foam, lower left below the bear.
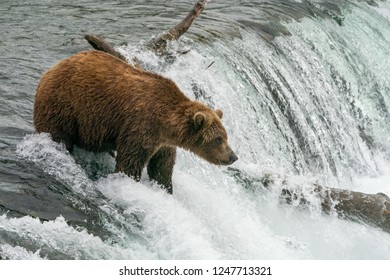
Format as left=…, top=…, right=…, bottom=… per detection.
left=0, top=158, right=109, bottom=238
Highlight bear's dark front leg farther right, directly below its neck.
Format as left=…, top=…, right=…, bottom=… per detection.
left=148, top=147, right=176, bottom=194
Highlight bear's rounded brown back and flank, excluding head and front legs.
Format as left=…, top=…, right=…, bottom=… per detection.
left=34, top=51, right=189, bottom=151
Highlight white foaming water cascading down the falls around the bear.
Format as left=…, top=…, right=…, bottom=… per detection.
left=0, top=2, right=390, bottom=259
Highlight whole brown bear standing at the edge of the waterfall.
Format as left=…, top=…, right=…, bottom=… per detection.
left=34, top=51, right=237, bottom=193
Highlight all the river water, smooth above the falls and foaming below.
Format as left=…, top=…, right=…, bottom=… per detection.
left=0, top=0, right=390, bottom=259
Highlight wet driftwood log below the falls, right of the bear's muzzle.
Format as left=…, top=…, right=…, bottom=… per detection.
left=227, top=167, right=390, bottom=233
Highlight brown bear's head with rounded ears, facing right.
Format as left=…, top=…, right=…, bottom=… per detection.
left=188, top=108, right=238, bottom=165
